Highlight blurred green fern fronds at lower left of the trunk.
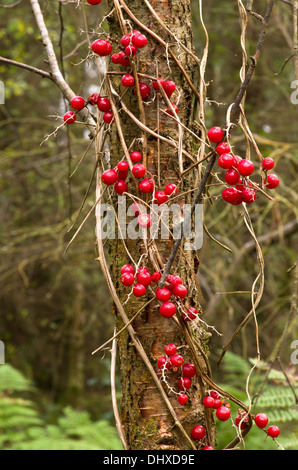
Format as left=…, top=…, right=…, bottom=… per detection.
left=0, top=365, right=121, bottom=450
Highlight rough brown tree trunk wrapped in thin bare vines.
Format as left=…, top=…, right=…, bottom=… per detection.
left=105, top=0, right=215, bottom=450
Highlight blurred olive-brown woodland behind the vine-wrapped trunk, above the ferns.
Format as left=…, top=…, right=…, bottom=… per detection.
left=0, top=0, right=298, bottom=448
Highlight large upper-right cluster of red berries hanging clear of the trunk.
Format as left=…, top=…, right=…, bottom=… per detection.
left=208, top=127, right=279, bottom=206
